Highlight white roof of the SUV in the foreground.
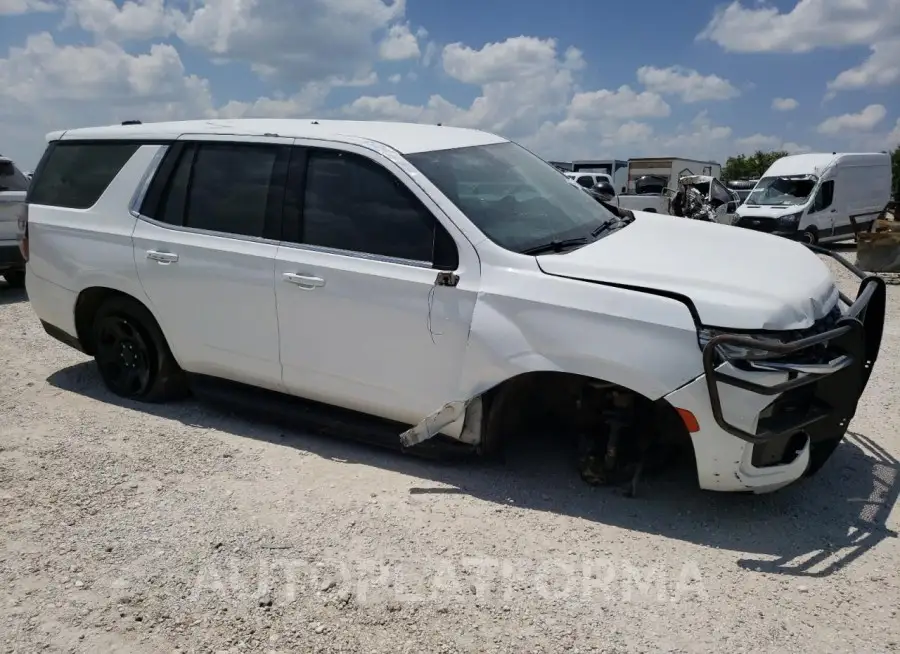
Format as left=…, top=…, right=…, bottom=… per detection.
left=47, top=118, right=506, bottom=154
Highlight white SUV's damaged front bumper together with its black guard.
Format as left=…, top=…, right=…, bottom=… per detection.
left=667, top=246, right=886, bottom=492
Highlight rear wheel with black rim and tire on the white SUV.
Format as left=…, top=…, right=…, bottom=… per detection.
left=90, top=296, right=188, bottom=403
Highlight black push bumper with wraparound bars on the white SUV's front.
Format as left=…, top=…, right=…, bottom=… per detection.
left=703, top=245, right=886, bottom=454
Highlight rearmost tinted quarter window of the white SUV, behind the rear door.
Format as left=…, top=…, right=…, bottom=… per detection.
left=28, top=141, right=140, bottom=209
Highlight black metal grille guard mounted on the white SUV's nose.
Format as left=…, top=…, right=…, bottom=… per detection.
left=703, top=245, right=887, bottom=444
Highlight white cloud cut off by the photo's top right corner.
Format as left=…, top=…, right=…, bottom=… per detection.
left=697, top=0, right=900, bottom=52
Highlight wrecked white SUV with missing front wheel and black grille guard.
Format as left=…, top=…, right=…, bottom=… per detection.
left=21, top=120, right=885, bottom=492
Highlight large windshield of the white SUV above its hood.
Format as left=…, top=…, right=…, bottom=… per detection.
left=406, top=142, right=617, bottom=252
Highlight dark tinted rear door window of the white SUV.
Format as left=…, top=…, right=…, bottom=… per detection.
left=183, top=143, right=278, bottom=236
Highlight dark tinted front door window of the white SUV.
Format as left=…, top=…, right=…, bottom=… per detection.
left=300, top=150, right=437, bottom=262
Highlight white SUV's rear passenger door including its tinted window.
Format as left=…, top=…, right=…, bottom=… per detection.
left=133, top=137, right=290, bottom=390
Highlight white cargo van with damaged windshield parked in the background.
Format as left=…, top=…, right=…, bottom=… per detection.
left=734, top=152, right=891, bottom=243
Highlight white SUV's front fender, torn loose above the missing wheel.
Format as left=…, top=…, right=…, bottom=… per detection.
left=400, top=269, right=702, bottom=447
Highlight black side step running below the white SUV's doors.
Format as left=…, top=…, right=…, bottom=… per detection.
left=188, top=375, right=475, bottom=461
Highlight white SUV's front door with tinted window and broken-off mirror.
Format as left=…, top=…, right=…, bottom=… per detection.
left=275, top=145, right=479, bottom=424
